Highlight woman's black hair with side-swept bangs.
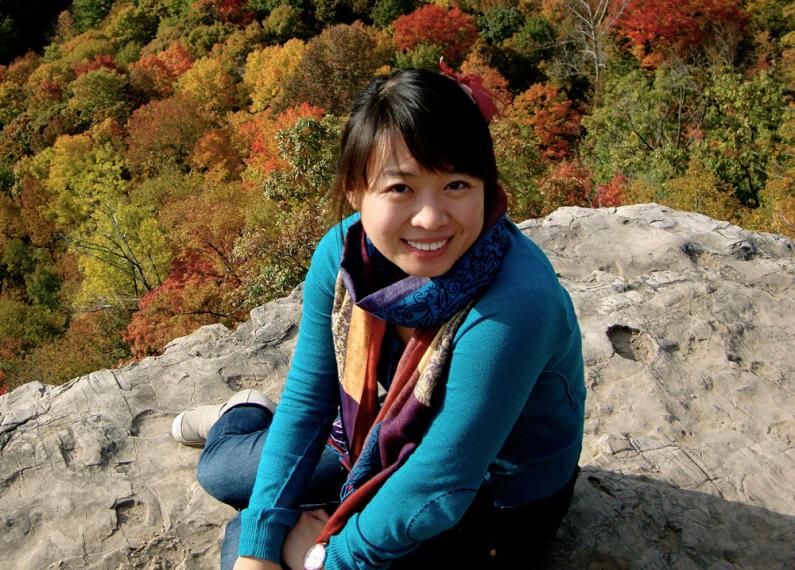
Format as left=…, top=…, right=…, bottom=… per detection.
left=333, top=69, right=497, bottom=215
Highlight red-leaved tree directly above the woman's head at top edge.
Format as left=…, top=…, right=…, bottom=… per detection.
left=392, top=4, right=478, bottom=63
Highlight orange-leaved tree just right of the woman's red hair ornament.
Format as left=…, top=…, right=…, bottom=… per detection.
left=511, top=83, right=582, bottom=162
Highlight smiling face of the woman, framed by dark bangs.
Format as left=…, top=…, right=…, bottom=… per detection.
left=349, top=141, right=484, bottom=277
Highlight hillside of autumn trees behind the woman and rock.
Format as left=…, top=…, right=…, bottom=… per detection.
left=0, top=0, right=795, bottom=393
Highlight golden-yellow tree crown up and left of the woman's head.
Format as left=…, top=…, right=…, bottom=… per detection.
left=243, top=39, right=306, bottom=113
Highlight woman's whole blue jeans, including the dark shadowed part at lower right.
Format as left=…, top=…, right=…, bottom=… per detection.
left=196, top=405, right=579, bottom=570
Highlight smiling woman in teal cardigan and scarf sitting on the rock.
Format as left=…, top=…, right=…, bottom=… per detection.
left=174, top=70, right=585, bottom=570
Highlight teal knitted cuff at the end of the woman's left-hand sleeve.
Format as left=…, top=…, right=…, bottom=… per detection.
left=237, top=509, right=300, bottom=562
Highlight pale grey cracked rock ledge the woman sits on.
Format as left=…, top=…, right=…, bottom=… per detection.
left=0, top=205, right=795, bottom=569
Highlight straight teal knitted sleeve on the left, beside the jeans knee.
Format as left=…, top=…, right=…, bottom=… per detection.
left=238, top=227, right=341, bottom=562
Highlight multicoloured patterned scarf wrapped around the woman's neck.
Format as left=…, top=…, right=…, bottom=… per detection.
left=317, top=186, right=508, bottom=543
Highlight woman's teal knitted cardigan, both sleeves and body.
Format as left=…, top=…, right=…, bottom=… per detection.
left=239, top=216, right=585, bottom=570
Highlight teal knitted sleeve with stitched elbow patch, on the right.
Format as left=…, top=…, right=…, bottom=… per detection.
left=326, top=266, right=572, bottom=570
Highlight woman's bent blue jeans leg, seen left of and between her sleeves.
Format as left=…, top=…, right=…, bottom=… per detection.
left=196, top=405, right=347, bottom=570
